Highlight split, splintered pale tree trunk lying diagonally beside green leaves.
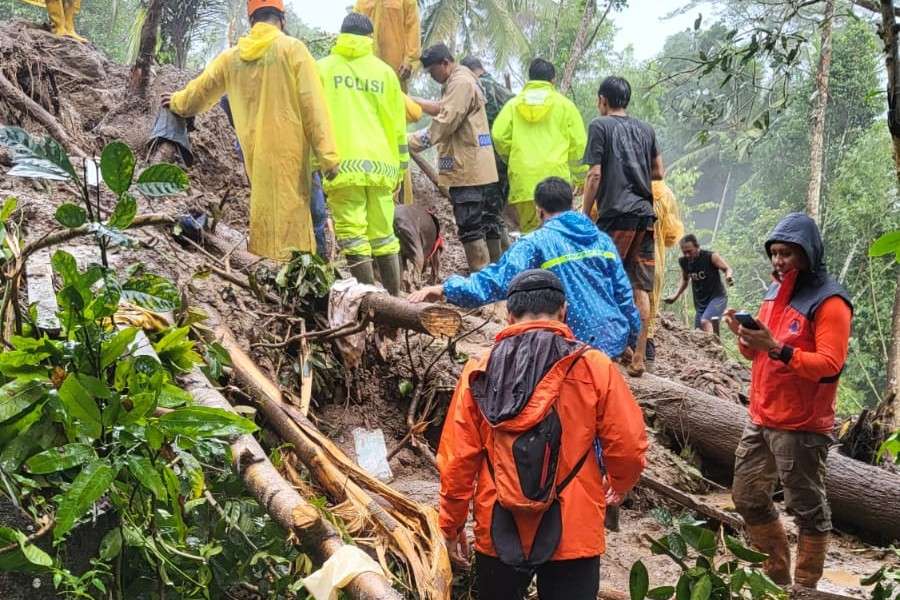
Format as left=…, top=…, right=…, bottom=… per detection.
left=210, top=322, right=452, bottom=600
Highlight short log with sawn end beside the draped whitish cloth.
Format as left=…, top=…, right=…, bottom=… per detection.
left=360, top=294, right=462, bottom=337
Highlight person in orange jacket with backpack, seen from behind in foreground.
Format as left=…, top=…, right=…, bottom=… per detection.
left=438, top=269, right=647, bottom=600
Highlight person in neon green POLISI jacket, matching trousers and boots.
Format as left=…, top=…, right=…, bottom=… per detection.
left=318, top=13, right=409, bottom=296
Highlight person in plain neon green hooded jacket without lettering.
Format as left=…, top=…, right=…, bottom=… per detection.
left=491, top=58, right=587, bottom=233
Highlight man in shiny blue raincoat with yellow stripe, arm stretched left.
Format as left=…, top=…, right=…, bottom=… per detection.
left=409, top=177, right=641, bottom=358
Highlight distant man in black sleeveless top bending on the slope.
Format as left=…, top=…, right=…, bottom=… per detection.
left=666, top=234, right=734, bottom=335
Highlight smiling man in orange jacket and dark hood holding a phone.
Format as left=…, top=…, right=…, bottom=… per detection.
left=725, top=213, right=853, bottom=589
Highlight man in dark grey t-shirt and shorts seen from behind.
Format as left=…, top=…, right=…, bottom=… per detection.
left=583, top=77, right=665, bottom=377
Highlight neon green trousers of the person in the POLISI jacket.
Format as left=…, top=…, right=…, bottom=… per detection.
left=328, top=186, right=400, bottom=256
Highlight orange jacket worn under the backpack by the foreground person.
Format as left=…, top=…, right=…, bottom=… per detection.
left=438, top=321, right=647, bottom=560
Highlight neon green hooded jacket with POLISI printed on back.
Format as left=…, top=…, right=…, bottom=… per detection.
left=318, top=33, right=409, bottom=192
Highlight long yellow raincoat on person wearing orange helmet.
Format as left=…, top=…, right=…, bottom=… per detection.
left=171, top=23, right=339, bottom=259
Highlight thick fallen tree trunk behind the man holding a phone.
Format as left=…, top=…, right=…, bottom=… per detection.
left=629, top=375, right=900, bottom=542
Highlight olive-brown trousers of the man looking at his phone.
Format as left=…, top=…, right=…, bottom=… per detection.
left=732, top=423, right=832, bottom=534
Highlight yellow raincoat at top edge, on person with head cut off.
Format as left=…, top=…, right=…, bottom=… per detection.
left=353, top=0, right=422, bottom=71
